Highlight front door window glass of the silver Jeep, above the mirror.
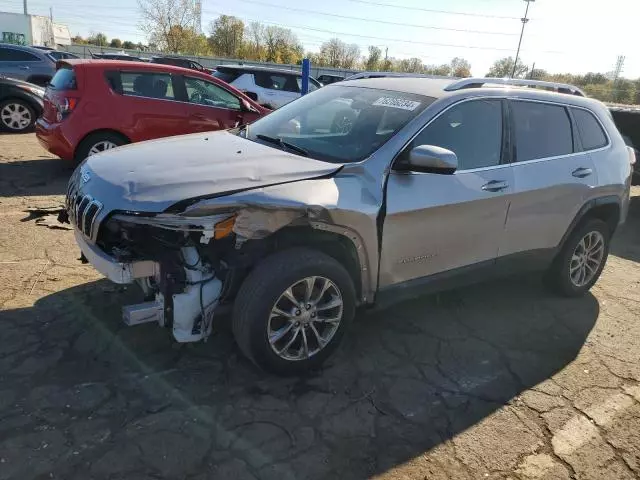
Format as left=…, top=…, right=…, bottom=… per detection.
left=409, top=100, right=502, bottom=170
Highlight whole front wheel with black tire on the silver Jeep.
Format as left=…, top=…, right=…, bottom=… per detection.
left=233, top=248, right=356, bottom=375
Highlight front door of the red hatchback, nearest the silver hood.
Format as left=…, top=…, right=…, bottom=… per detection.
left=183, top=76, right=254, bottom=132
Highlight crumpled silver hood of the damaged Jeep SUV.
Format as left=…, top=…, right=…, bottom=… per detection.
left=80, top=131, right=342, bottom=213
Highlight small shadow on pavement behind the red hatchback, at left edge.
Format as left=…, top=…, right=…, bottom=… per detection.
left=0, top=158, right=73, bottom=197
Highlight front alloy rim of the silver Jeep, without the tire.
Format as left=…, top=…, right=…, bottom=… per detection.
left=267, top=276, right=344, bottom=361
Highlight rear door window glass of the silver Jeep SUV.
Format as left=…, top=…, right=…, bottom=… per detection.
left=511, top=101, right=573, bottom=162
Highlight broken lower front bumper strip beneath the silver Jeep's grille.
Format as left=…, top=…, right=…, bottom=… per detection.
left=74, top=230, right=160, bottom=284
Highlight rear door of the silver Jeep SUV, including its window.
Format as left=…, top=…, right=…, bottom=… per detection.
left=500, top=100, right=606, bottom=256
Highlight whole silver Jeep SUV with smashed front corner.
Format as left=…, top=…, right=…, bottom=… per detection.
left=61, top=78, right=634, bottom=374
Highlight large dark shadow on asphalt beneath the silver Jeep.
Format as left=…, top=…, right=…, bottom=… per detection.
left=0, top=279, right=599, bottom=480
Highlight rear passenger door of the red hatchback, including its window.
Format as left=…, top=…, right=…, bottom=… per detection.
left=107, top=70, right=190, bottom=142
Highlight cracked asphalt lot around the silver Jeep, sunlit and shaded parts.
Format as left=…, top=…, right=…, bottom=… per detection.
left=0, top=134, right=640, bottom=480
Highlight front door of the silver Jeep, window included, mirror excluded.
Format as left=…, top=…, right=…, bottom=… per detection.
left=379, top=99, right=513, bottom=288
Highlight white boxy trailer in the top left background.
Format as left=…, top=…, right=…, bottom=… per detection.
left=0, top=12, right=71, bottom=47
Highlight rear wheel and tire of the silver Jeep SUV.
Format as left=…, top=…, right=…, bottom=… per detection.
left=547, top=218, right=611, bottom=297
